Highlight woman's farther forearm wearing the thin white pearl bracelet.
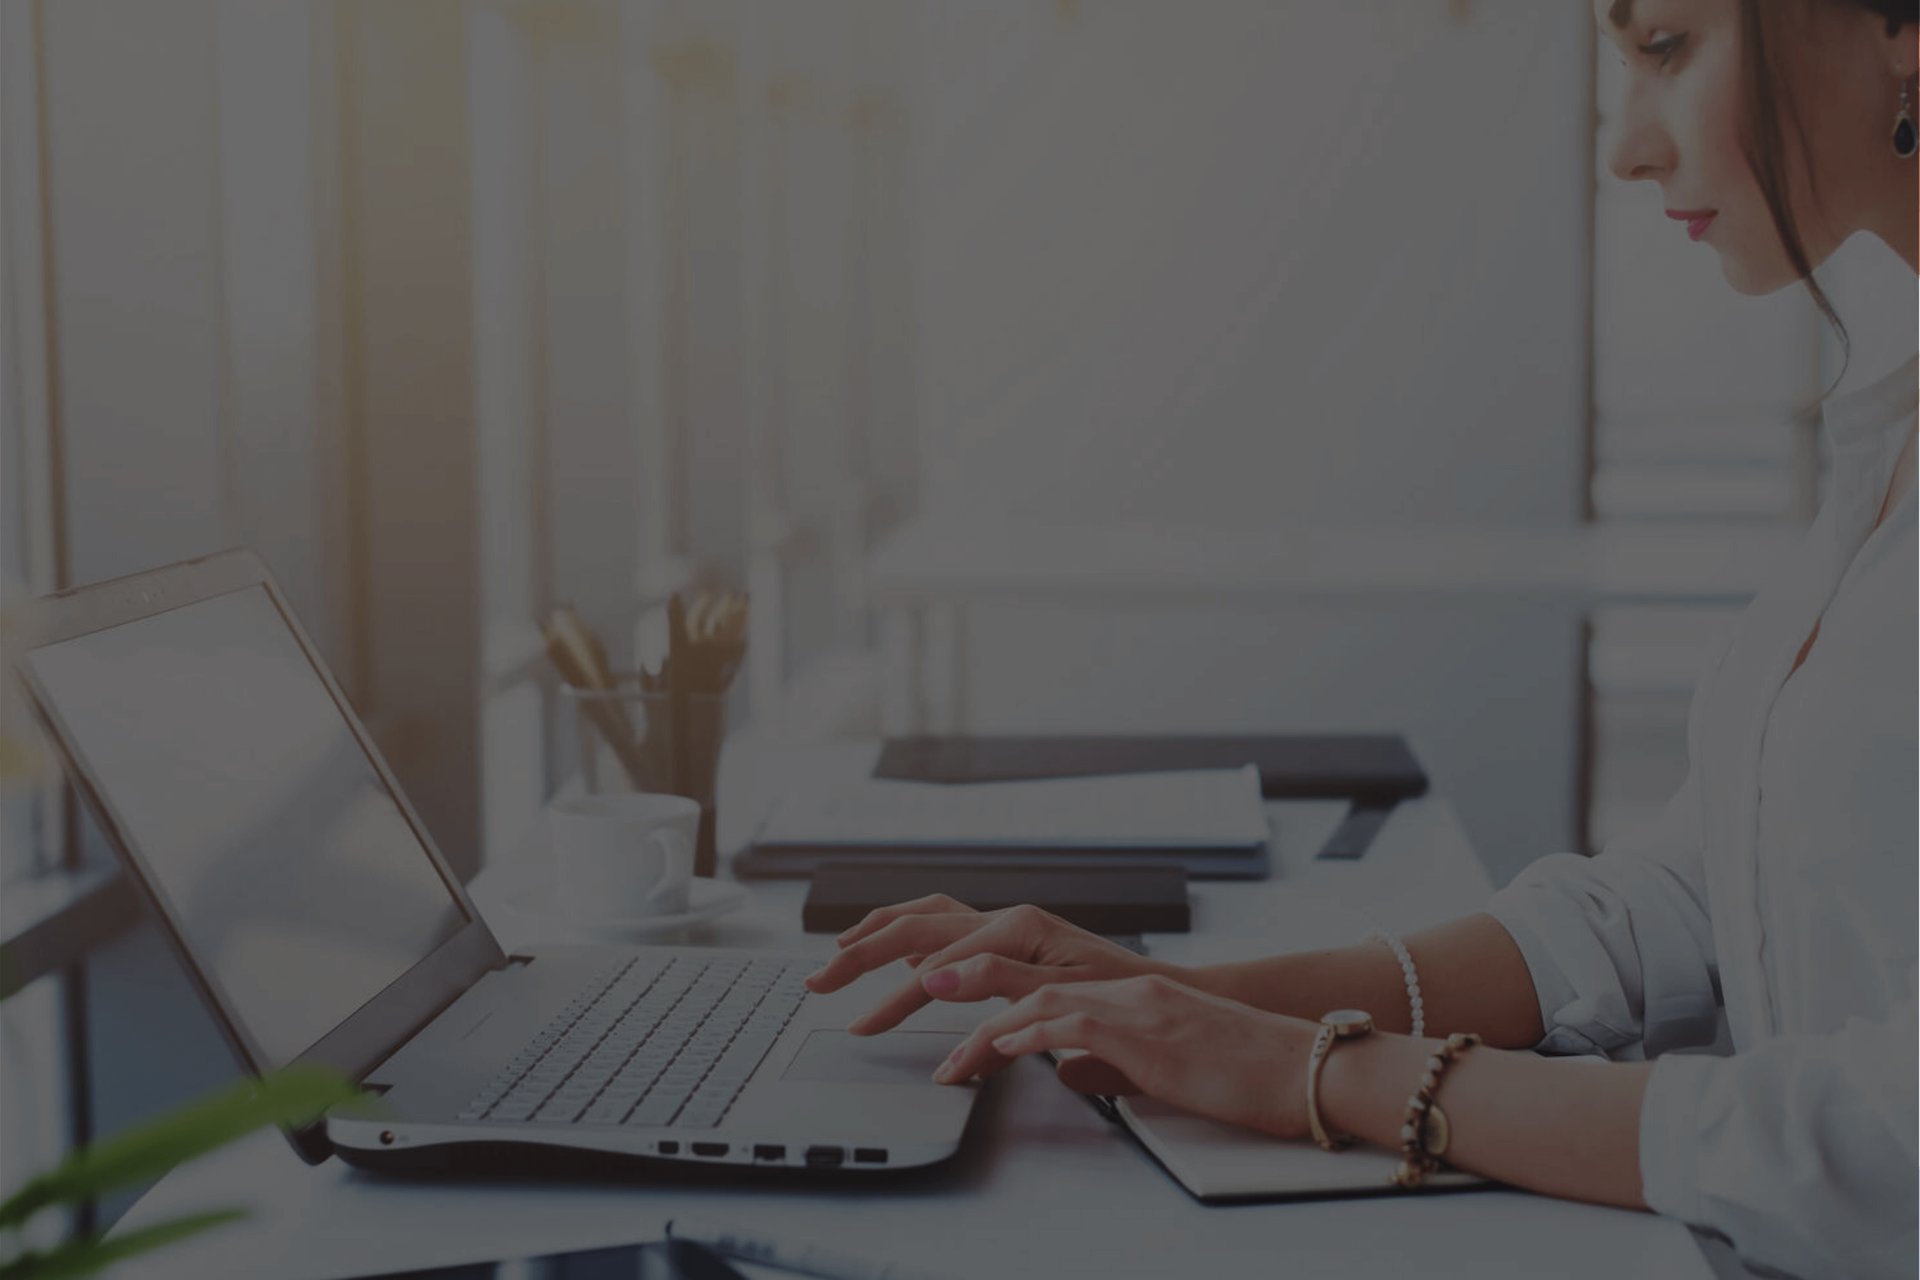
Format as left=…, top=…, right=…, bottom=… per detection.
left=1175, top=913, right=1546, bottom=1048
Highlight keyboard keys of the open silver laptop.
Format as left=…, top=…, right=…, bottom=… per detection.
left=459, top=956, right=806, bottom=1128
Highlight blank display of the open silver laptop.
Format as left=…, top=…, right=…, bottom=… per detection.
left=27, top=585, right=467, bottom=1063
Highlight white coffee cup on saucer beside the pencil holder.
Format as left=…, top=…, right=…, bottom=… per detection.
left=547, top=793, right=701, bottom=919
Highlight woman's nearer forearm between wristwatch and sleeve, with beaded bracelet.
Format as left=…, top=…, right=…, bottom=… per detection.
left=1321, top=1034, right=1653, bottom=1209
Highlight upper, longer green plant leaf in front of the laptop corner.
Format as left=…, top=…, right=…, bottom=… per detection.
left=0, top=1065, right=355, bottom=1226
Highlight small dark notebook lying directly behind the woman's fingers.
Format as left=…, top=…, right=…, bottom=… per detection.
left=801, top=862, right=1192, bottom=933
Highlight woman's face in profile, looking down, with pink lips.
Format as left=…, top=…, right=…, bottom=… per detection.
left=1594, top=0, right=1899, bottom=294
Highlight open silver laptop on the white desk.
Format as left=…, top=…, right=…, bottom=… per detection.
left=26, top=551, right=977, bottom=1174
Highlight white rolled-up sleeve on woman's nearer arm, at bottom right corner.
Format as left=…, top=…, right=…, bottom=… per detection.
left=1640, top=998, right=1920, bottom=1276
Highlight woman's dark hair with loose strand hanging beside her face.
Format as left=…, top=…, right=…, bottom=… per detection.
left=1740, top=0, right=1920, bottom=351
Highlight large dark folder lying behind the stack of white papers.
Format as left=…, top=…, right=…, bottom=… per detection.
left=874, top=733, right=1427, bottom=806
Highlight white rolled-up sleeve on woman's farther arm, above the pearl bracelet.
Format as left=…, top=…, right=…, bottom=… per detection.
left=1486, top=777, right=1720, bottom=1057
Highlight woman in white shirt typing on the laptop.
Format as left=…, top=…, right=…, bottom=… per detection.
left=810, top=0, right=1920, bottom=1276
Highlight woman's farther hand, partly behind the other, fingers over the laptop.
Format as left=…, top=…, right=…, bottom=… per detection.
left=806, top=894, right=1177, bottom=1036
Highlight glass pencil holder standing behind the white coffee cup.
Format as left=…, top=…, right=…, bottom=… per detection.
left=561, top=676, right=728, bottom=875
